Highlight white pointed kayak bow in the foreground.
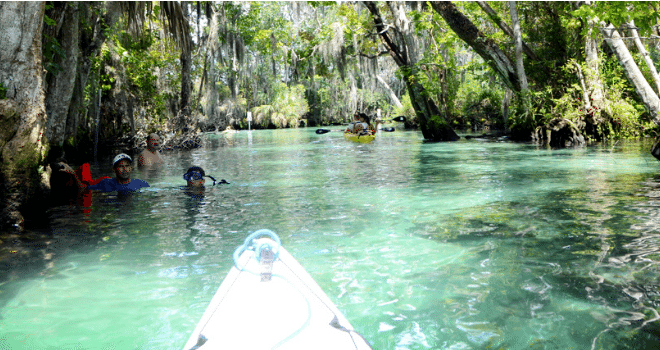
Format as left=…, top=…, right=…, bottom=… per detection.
left=184, top=231, right=371, bottom=350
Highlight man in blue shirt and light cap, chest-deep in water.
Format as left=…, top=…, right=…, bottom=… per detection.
left=63, top=153, right=149, bottom=192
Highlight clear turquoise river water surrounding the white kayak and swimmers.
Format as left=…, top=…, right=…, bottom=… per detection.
left=0, top=129, right=660, bottom=350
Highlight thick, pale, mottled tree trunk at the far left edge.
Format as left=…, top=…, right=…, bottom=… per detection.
left=0, top=1, right=48, bottom=229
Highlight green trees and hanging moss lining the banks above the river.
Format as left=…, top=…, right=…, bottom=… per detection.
left=0, top=1, right=660, bottom=230
